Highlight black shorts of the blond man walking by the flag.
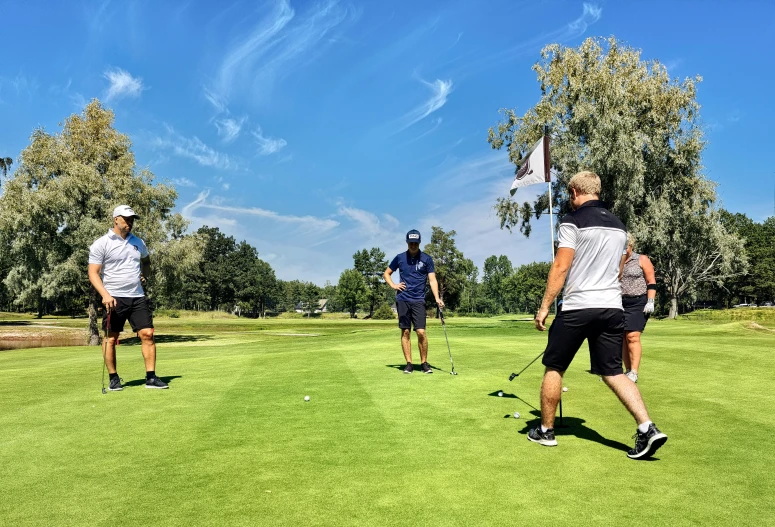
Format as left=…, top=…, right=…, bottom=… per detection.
left=543, top=309, right=624, bottom=375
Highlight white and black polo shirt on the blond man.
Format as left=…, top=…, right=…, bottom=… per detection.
left=558, top=200, right=627, bottom=311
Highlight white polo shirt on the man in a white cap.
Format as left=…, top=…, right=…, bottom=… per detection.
left=89, top=229, right=148, bottom=298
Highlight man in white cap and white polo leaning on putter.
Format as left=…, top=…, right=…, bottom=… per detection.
left=89, top=205, right=169, bottom=392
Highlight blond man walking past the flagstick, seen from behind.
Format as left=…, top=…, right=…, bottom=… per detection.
left=527, top=172, right=667, bottom=459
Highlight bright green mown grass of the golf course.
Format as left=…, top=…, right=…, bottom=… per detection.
left=0, top=316, right=775, bottom=526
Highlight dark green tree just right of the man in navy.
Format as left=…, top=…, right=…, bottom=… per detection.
left=423, top=227, right=468, bottom=309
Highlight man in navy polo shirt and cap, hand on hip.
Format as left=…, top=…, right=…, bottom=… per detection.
left=382, top=229, right=444, bottom=373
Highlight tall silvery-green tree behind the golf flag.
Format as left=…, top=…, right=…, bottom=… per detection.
left=488, top=37, right=745, bottom=316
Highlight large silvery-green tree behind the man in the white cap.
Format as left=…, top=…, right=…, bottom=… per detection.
left=0, top=99, right=183, bottom=343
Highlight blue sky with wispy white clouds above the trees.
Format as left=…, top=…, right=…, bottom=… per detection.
left=0, top=0, right=775, bottom=284
